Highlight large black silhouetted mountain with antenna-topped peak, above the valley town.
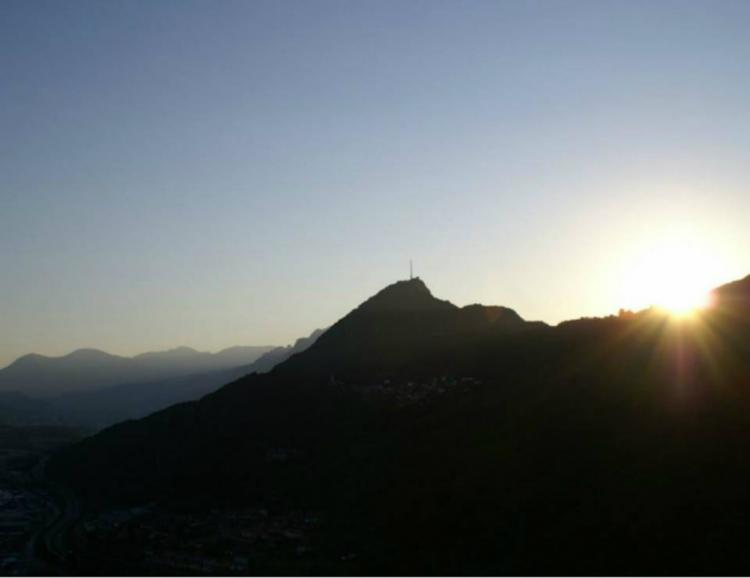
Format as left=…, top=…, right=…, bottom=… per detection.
left=48, top=279, right=750, bottom=575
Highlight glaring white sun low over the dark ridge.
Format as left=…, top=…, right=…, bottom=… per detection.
left=622, top=234, right=721, bottom=317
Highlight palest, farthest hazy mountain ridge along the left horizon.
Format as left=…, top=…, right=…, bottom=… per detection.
left=0, top=346, right=273, bottom=397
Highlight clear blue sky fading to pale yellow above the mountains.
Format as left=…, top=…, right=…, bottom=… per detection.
left=0, top=0, right=750, bottom=365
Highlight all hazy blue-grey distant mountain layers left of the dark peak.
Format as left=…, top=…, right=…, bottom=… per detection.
left=0, top=330, right=322, bottom=430
